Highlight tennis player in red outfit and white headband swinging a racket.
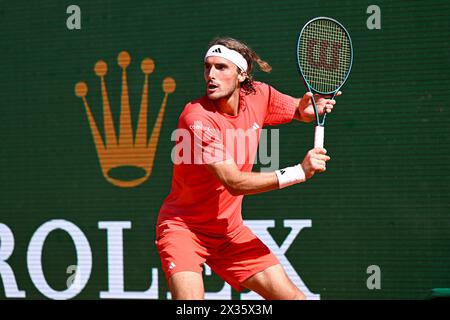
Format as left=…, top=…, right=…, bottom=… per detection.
left=155, top=38, right=335, bottom=299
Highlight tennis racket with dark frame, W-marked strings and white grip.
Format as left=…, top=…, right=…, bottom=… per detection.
left=297, top=17, right=353, bottom=148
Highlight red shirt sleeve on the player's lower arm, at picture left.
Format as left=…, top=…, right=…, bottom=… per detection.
left=179, top=113, right=232, bottom=164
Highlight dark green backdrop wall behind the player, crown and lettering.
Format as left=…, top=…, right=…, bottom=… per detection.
left=0, top=0, right=450, bottom=299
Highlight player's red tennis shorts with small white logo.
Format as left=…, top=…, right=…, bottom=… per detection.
left=155, top=224, right=279, bottom=292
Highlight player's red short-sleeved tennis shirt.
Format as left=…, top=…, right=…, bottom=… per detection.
left=157, top=82, right=298, bottom=236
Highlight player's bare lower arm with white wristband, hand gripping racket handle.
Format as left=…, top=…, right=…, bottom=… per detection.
left=206, top=148, right=330, bottom=196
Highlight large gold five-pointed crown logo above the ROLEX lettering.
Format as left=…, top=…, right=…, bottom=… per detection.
left=75, top=51, right=176, bottom=187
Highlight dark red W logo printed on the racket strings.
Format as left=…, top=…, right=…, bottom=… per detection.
left=307, top=39, right=342, bottom=71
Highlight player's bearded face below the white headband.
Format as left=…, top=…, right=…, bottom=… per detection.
left=204, top=57, right=245, bottom=100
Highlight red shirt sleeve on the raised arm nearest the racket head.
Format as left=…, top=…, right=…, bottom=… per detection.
left=264, top=86, right=298, bottom=126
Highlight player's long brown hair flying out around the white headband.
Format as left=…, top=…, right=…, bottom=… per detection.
left=209, top=37, right=272, bottom=94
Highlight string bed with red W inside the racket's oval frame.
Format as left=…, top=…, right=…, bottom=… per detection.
left=298, top=19, right=352, bottom=92
